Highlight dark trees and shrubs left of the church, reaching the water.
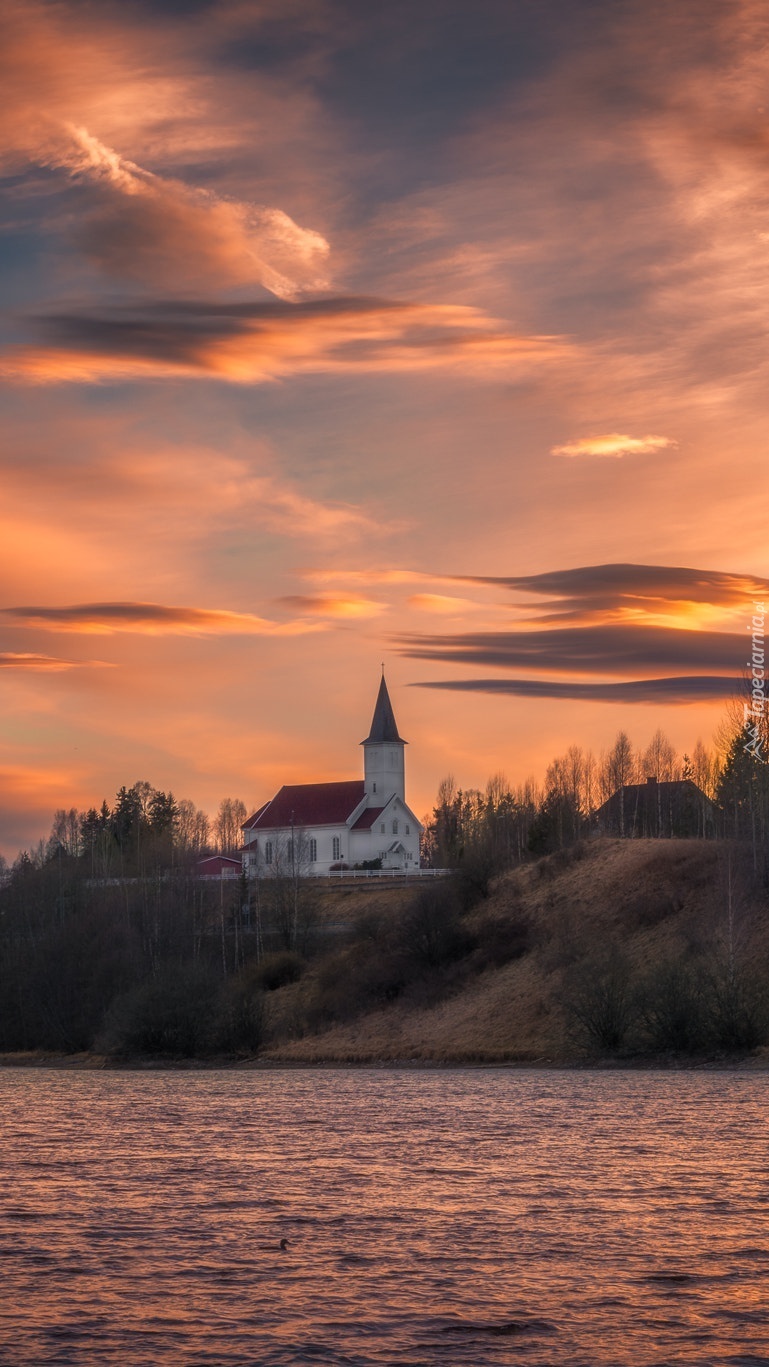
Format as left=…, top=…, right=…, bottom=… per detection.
left=0, top=781, right=313, bottom=1054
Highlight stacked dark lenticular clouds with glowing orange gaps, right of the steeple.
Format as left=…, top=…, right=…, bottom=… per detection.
left=399, top=565, right=769, bottom=703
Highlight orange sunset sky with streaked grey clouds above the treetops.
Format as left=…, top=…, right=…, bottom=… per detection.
left=0, top=0, right=769, bottom=857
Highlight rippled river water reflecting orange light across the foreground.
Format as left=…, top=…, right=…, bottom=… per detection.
left=0, top=1068, right=769, bottom=1367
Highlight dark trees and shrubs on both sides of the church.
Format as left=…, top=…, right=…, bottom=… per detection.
left=0, top=704, right=769, bottom=1058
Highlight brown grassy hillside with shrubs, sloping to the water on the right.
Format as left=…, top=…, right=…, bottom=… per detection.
left=255, top=839, right=769, bottom=1064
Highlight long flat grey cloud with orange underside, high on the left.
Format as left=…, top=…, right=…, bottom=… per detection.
left=0, top=298, right=572, bottom=384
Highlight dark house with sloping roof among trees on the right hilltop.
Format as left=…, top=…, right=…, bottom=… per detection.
left=596, top=778, right=718, bottom=839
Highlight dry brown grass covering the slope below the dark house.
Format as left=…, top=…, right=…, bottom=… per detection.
left=262, top=839, right=769, bottom=1064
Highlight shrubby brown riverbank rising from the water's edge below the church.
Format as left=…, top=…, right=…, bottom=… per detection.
left=0, top=839, right=769, bottom=1070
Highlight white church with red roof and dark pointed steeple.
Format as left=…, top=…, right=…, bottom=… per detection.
left=243, top=673, right=422, bottom=878
